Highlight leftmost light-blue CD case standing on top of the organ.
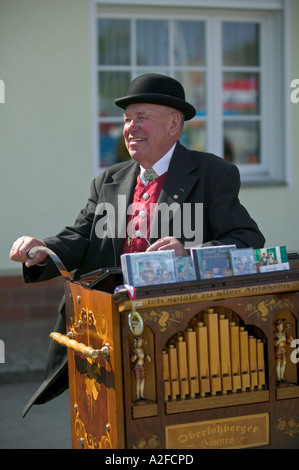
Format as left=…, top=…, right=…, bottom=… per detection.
left=120, top=250, right=177, bottom=287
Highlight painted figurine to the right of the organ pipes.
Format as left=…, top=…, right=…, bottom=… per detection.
left=274, top=318, right=293, bottom=385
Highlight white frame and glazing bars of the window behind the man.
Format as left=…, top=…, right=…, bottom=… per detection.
left=93, top=0, right=289, bottom=186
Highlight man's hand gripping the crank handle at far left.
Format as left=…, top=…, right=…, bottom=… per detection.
left=9, top=235, right=47, bottom=268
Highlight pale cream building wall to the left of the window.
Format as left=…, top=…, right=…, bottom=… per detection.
left=0, top=0, right=92, bottom=274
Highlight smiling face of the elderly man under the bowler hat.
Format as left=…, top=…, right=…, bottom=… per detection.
left=123, top=103, right=180, bottom=168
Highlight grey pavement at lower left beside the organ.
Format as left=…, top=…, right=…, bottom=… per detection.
left=0, top=320, right=72, bottom=449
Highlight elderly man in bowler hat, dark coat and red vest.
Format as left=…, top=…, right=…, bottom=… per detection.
left=10, top=74, right=265, bottom=412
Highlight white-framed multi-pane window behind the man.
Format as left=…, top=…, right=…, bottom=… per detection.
left=96, top=7, right=285, bottom=184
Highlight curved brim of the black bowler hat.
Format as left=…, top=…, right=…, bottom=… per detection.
left=115, top=93, right=196, bottom=121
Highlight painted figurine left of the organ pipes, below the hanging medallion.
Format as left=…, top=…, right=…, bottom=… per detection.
left=131, top=336, right=151, bottom=402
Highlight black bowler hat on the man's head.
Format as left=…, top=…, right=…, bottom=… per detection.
left=115, top=73, right=196, bottom=121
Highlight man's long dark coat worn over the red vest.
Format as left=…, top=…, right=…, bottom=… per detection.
left=24, top=143, right=265, bottom=413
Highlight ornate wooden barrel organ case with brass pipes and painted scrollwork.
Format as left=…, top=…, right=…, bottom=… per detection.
left=52, top=266, right=299, bottom=449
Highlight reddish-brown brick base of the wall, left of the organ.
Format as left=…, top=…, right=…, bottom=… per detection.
left=0, top=276, right=64, bottom=322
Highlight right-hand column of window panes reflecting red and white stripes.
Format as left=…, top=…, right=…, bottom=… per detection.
left=222, top=22, right=260, bottom=165
